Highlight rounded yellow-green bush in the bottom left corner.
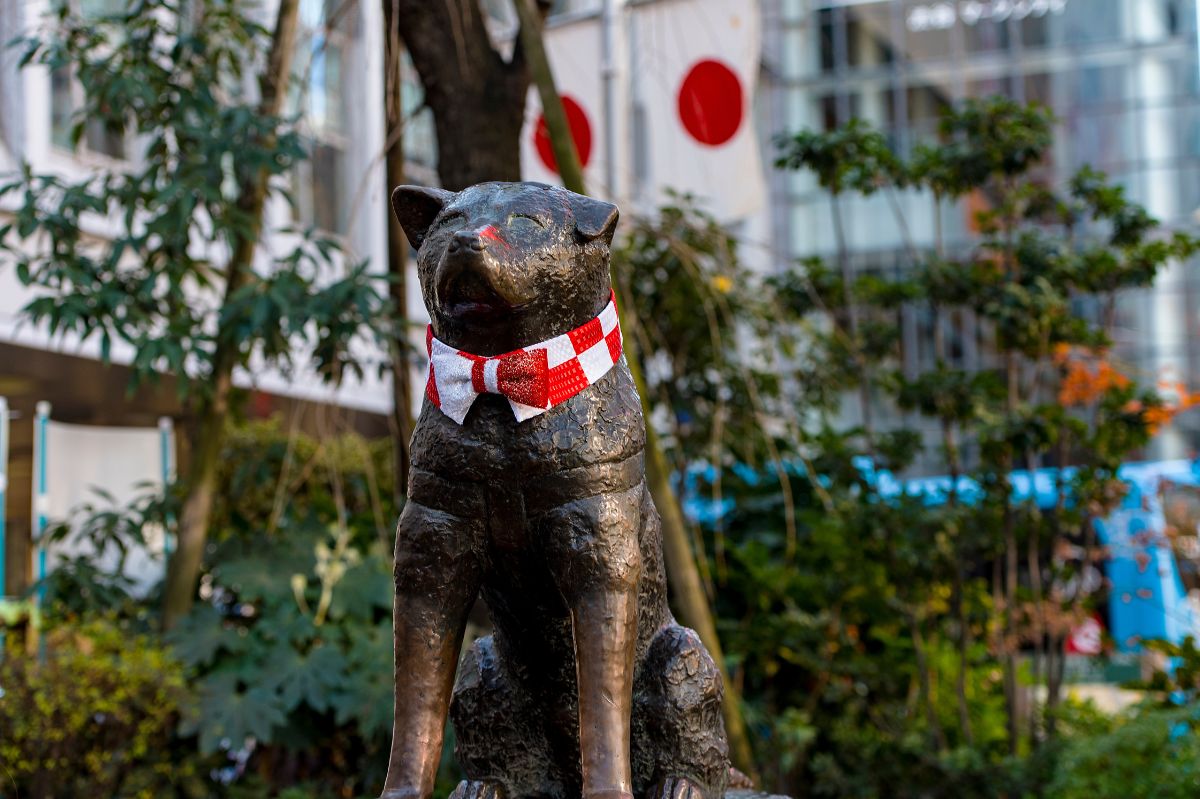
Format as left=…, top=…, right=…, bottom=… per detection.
left=0, top=619, right=205, bottom=799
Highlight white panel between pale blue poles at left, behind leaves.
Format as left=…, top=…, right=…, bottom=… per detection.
left=37, top=421, right=174, bottom=594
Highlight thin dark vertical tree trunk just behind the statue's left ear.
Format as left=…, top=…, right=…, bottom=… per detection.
left=383, top=0, right=413, bottom=504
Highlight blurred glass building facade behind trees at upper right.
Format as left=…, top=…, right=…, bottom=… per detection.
left=758, top=0, right=1200, bottom=470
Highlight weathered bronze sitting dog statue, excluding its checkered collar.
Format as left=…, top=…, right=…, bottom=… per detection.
left=383, top=184, right=730, bottom=799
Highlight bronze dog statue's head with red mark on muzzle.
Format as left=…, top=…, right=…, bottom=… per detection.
left=391, top=182, right=617, bottom=355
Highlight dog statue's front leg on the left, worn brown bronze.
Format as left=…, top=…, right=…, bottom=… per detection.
left=382, top=499, right=482, bottom=799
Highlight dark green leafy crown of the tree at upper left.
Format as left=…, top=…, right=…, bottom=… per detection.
left=0, top=0, right=386, bottom=401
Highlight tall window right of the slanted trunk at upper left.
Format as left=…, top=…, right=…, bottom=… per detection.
left=290, top=0, right=360, bottom=234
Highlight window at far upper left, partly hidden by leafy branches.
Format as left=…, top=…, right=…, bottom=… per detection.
left=50, top=0, right=128, bottom=160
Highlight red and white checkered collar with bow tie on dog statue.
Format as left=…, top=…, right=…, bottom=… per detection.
left=425, top=289, right=620, bottom=425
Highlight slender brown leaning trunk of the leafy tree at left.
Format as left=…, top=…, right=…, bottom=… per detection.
left=162, top=0, right=299, bottom=630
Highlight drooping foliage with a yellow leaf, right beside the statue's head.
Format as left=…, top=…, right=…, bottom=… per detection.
left=613, top=197, right=792, bottom=463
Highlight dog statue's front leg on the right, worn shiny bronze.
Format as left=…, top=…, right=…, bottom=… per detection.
left=544, top=486, right=642, bottom=799
